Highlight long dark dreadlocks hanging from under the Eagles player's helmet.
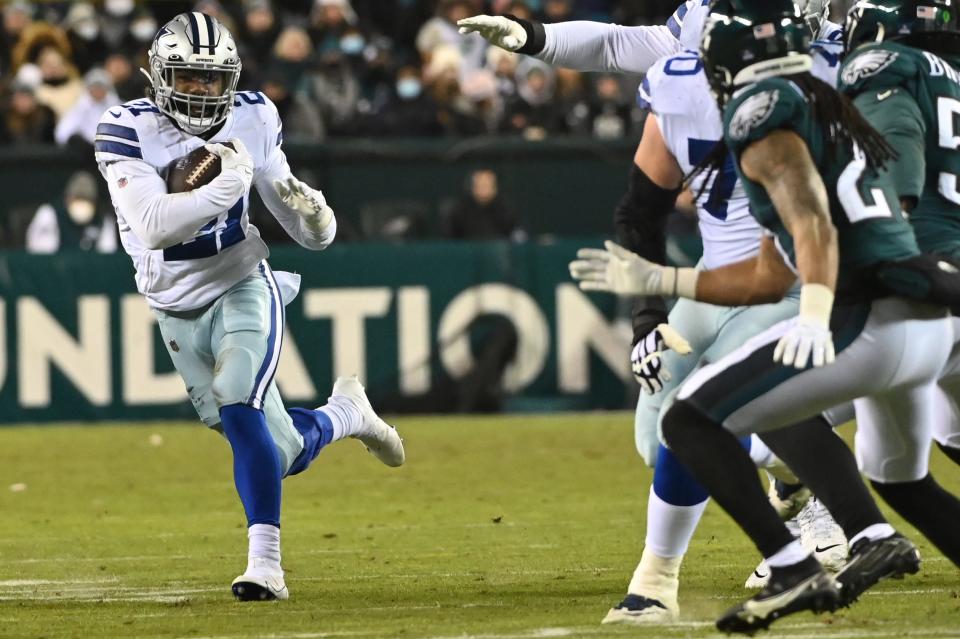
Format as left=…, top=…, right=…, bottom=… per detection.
left=686, top=73, right=897, bottom=199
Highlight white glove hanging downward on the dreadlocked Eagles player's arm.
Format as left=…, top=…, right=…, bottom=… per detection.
left=773, top=284, right=836, bottom=369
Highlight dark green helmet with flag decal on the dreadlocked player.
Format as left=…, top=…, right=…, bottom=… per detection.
left=700, top=0, right=813, bottom=106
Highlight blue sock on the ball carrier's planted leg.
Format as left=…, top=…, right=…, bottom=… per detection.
left=220, top=404, right=282, bottom=527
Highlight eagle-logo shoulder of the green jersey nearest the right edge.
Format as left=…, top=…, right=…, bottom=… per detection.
left=839, top=42, right=920, bottom=95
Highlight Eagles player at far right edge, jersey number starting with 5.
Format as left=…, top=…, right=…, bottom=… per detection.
left=840, top=0, right=960, bottom=565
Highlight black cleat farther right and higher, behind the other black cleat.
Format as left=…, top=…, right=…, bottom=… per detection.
left=836, top=533, right=920, bottom=607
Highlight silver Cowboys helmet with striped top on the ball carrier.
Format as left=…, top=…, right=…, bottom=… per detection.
left=144, top=11, right=240, bottom=135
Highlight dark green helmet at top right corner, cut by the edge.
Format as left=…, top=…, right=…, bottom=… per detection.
left=843, top=0, right=960, bottom=51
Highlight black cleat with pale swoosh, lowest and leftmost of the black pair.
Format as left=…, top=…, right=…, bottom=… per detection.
left=717, top=557, right=840, bottom=635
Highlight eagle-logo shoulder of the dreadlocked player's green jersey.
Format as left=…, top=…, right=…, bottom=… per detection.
left=723, top=79, right=806, bottom=150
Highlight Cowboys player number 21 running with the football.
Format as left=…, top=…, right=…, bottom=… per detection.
left=95, top=12, right=404, bottom=600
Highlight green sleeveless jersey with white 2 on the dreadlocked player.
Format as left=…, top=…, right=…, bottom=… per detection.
left=724, top=78, right=919, bottom=297
